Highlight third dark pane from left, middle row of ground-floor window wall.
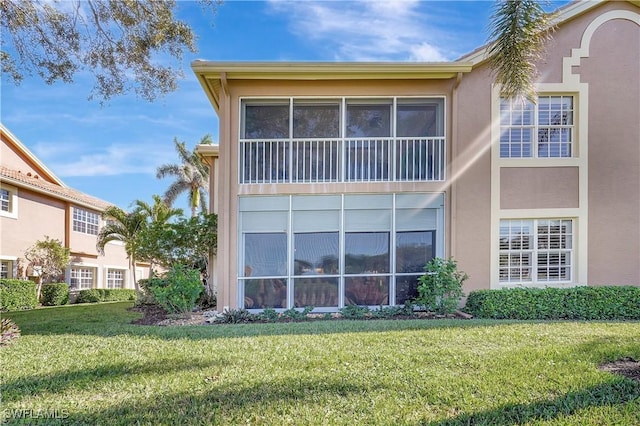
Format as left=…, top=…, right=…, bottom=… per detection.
left=344, top=232, right=389, bottom=274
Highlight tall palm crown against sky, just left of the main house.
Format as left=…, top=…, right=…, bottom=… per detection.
left=156, top=135, right=213, bottom=217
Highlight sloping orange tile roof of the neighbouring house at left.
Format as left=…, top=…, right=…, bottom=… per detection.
left=0, top=166, right=112, bottom=211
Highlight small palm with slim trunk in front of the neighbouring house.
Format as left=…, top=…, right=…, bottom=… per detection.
left=96, top=206, right=146, bottom=296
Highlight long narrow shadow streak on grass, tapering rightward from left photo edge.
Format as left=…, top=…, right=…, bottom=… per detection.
left=2, top=359, right=229, bottom=403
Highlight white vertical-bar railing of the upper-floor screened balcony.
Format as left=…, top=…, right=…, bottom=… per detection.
left=240, top=137, right=445, bottom=184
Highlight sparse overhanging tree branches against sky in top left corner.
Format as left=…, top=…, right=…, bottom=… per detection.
left=0, top=0, right=220, bottom=101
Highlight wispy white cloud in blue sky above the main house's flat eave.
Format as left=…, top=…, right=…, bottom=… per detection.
left=270, top=0, right=452, bottom=62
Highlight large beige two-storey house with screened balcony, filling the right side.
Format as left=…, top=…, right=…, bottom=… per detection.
left=192, top=1, right=640, bottom=311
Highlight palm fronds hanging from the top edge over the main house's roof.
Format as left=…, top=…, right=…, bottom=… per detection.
left=488, top=0, right=553, bottom=103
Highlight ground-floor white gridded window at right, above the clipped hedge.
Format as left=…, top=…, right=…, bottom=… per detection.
left=500, top=219, right=574, bottom=284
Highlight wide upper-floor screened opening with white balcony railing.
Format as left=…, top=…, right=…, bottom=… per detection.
left=239, top=98, right=445, bottom=183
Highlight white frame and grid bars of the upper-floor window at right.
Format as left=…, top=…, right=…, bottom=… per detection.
left=498, top=93, right=578, bottom=160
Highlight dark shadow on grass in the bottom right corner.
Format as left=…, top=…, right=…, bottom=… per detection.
left=421, top=378, right=640, bottom=426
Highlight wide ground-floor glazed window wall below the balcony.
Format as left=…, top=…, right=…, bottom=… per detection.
left=238, top=194, right=443, bottom=310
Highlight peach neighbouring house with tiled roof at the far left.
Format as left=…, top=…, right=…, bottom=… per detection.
left=0, top=124, right=149, bottom=292
